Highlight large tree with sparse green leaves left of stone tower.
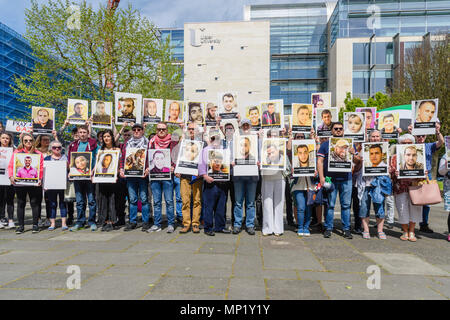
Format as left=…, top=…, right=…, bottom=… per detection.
left=13, top=0, right=181, bottom=131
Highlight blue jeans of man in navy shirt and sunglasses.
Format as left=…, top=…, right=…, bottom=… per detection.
left=325, top=179, right=352, bottom=231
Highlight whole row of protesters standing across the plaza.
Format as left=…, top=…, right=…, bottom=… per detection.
left=0, top=112, right=450, bottom=242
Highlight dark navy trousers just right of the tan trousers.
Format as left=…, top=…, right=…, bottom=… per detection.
left=202, top=182, right=228, bottom=232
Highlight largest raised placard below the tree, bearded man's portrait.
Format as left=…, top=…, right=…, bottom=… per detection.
left=114, top=92, right=142, bottom=124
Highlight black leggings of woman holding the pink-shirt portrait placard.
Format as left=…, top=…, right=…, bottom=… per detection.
left=15, top=186, right=42, bottom=227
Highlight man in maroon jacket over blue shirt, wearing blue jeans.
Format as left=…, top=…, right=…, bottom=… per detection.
left=67, top=125, right=98, bottom=231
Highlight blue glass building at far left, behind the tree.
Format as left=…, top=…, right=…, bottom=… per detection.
left=0, top=22, right=35, bottom=124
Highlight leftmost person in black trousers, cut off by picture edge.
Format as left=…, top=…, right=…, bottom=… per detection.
left=0, top=132, right=16, bottom=230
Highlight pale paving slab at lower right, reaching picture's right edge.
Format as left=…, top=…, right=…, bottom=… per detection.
left=364, top=252, right=450, bottom=276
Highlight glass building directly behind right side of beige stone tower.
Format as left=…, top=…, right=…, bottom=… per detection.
left=244, top=1, right=328, bottom=114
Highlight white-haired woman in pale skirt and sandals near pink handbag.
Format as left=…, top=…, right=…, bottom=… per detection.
left=389, top=134, right=422, bottom=242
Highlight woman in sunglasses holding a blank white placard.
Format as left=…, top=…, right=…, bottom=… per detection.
left=44, top=140, right=69, bottom=231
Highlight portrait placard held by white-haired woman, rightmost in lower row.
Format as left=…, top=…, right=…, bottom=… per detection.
left=396, top=144, right=425, bottom=178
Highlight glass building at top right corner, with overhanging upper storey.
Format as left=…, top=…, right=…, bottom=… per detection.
left=329, top=0, right=450, bottom=101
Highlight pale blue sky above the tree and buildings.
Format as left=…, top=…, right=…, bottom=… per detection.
left=0, top=0, right=320, bottom=34
